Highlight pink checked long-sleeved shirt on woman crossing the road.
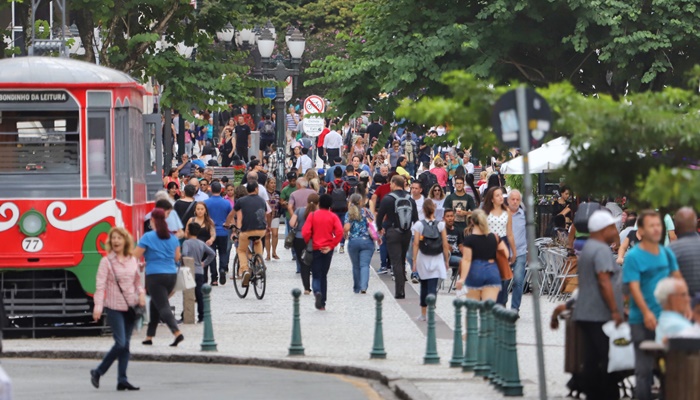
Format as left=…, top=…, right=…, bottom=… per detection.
left=94, top=252, right=145, bottom=313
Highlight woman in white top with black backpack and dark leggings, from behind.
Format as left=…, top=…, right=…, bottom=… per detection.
left=411, top=199, right=450, bottom=321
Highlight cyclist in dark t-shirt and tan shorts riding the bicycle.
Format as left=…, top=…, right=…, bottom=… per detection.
left=233, top=182, right=270, bottom=287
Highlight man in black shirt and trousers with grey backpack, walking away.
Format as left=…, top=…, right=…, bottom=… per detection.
left=376, top=175, right=418, bottom=299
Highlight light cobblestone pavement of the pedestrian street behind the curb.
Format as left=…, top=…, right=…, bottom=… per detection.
left=4, top=242, right=568, bottom=400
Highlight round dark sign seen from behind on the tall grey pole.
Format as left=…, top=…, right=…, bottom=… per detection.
left=491, top=88, right=552, bottom=146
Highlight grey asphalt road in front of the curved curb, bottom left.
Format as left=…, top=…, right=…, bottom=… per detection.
left=3, top=359, right=395, bottom=400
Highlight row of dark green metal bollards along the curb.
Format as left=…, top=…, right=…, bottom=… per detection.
left=201, top=285, right=523, bottom=396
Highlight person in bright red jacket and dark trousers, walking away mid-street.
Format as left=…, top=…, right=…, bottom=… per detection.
left=301, top=194, right=343, bottom=311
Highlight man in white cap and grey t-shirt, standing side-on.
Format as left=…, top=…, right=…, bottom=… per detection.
left=573, top=210, right=623, bottom=400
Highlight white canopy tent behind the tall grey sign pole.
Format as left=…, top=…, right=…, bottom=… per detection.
left=501, top=137, right=571, bottom=175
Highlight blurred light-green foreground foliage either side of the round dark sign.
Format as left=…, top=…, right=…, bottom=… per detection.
left=397, top=71, right=700, bottom=207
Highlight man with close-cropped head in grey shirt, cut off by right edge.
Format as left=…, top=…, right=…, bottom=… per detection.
left=669, top=207, right=700, bottom=297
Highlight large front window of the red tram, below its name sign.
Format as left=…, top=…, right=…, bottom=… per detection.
left=0, top=111, right=80, bottom=174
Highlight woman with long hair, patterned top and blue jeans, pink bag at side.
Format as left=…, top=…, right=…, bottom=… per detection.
left=343, top=193, right=381, bottom=294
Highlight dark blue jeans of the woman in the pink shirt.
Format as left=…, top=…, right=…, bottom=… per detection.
left=97, top=308, right=134, bottom=383
